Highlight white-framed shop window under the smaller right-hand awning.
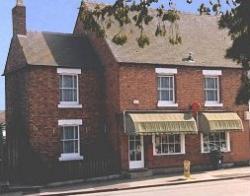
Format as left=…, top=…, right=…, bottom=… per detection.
left=201, top=132, right=230, bottom=153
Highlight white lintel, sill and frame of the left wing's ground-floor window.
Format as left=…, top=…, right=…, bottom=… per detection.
left=58, top=119, right=83, bottom=161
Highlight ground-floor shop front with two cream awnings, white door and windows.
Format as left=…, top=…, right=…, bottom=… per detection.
left=124, top=112, right=243, bottom=170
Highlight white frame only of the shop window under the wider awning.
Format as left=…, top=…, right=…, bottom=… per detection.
left=152, top=133, right=186, bottom=156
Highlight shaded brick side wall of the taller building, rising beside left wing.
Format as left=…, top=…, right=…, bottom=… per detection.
left=74, top=25, right=121, bottom=163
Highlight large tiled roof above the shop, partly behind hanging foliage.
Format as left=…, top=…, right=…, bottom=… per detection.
left=98, top=10, right=241, bottom=68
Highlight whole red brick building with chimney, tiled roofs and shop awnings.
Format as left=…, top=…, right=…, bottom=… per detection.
left=4, top=1, right=250, bottom=181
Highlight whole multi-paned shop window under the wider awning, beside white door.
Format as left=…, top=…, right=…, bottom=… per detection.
left=153, top=134, right=185, bottom=155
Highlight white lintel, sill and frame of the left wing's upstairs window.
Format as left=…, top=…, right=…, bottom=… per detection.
left=57, top=68, right=82, bottom=108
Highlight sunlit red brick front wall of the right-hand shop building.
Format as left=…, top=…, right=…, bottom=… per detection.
left=119, top=65, right=250, bottom=169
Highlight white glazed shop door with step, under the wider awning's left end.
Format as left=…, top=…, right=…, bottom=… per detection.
left=128, top=136, right=144, bottom=169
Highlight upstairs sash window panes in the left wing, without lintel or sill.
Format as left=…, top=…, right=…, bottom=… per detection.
left=59, top=75, right=78, bottom=103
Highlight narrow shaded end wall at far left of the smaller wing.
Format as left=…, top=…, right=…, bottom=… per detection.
left=5, top=69, right=29, bottom=177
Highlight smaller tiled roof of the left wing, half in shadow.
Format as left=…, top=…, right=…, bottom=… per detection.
left=18, top=32, right=99, bottom=67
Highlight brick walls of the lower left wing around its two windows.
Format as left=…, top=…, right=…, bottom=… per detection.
left=6, top=66, right=107, bottom=165
